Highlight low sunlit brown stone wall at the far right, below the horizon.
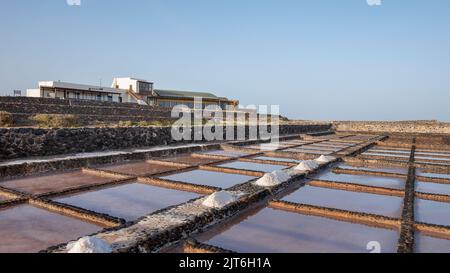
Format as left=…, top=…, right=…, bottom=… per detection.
left=333, top=120, right=450, bottom=134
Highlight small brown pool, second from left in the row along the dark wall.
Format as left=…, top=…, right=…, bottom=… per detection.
left=99, top=161, right=183, bottom=176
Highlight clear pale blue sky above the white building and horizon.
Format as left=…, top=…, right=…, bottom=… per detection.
left=0, top=0, right=450, bottom=121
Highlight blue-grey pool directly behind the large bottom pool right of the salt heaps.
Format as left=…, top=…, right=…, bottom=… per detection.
left=283, top=186, right=403, bottom=218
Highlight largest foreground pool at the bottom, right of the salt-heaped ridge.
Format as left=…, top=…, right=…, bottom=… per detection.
left=200, top=208, right=398, bottom=253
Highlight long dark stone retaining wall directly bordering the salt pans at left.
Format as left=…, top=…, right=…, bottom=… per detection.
left=0, top=124, right=331, bottom=160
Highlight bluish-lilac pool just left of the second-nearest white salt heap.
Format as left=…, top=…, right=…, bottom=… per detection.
left=56, top=183, right=200, bottom=221
